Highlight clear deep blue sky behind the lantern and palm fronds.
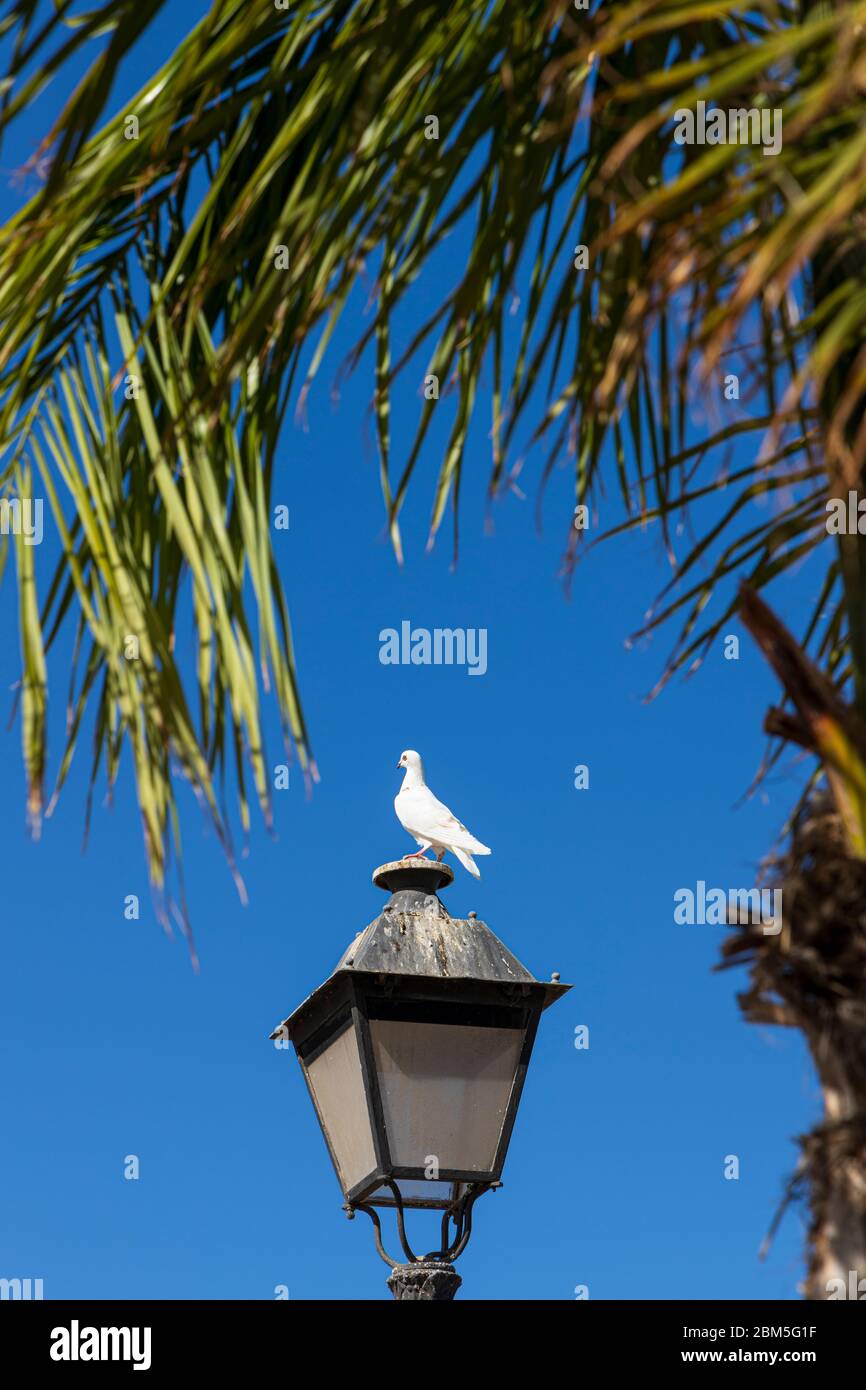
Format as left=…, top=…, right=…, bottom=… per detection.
left=0, top=6, right=820, bottom=1300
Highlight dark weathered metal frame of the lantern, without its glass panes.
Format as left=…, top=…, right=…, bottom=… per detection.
left=271, top=859, right=571, bottom=1268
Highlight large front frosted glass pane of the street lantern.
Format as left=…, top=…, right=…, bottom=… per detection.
left=370, top=1019, right=524, bottom=1173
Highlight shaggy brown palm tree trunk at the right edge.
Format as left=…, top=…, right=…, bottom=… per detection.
left=723, top=795, right=866, bottom=1300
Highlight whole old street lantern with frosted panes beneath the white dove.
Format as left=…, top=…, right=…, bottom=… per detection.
left=271, top=858, right=571, bottom=1301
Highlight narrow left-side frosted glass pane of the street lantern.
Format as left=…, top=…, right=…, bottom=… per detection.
left=304, top=1022, right=377, bottom=1193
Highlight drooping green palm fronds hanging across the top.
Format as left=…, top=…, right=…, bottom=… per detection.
left=0, top=0, right=866, bottom=922
